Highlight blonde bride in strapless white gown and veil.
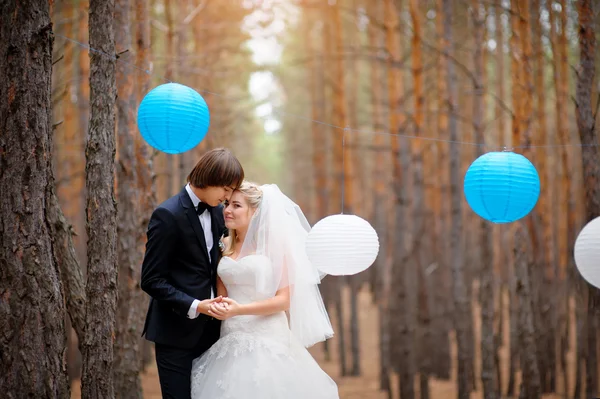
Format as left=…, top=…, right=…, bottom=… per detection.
left=191, top=182, right=339, bottom=399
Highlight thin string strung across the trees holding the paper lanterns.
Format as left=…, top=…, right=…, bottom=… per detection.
left=55, top=33, right=600, bottom=152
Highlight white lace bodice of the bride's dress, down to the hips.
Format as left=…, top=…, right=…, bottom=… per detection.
left=217, top=255, right=290, bottom=340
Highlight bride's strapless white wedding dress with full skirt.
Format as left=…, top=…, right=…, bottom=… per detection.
left=192, top=255, right=339, bottom=399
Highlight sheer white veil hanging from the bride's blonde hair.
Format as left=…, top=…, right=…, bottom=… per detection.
left=239, top=184, right=333, bottom=347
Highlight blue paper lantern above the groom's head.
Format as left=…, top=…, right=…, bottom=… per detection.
left=137, top=83, right=210, bottom=154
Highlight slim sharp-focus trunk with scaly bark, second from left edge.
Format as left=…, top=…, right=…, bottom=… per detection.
left=81, top=0, right=117, bottom=399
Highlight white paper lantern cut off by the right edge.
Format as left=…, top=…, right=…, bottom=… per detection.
left=575, top=217, right=600, bottom=288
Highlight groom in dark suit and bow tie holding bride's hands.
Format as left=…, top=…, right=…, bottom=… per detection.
left=141, top=148, right=244, bottom=399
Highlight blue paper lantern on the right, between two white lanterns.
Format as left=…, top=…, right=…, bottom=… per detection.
left=464, top=151, right=540, bottom=223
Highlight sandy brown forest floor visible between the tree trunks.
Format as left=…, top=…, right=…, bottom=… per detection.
left=71, top=289, right=573, bottom=399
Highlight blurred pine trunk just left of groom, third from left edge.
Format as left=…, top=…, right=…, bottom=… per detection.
left=114, top=0, right=145, bottom=399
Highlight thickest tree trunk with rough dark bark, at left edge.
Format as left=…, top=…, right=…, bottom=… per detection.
left=0, top=0, right=70, bottom=399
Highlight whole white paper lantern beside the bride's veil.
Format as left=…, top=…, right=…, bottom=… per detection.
left=306, top=215, right=379, bottom=276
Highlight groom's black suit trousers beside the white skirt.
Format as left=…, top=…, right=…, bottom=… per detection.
left=155, top=318, right=221, bottom=399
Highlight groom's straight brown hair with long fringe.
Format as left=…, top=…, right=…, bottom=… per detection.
left=187, top=148, right=244, bottom=189
